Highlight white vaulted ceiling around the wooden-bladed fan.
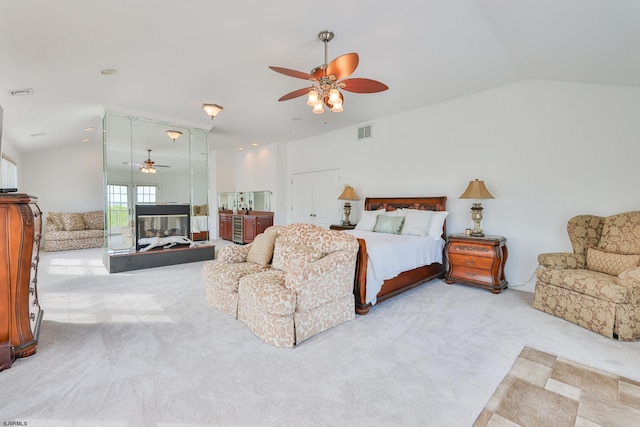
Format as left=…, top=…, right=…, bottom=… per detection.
left=0, top=0, right=640, bottom=152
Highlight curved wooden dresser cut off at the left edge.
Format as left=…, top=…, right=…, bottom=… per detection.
left=0, top=193, right=42, bottom=371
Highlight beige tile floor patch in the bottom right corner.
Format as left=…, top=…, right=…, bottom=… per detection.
left=474, top=347, right=640, bottom=427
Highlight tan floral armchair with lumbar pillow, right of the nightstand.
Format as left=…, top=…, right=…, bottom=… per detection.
left=533, top=211, right=640, bottom=341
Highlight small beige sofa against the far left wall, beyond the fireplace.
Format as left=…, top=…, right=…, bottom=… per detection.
left=44, top=211, right=104, bottom=251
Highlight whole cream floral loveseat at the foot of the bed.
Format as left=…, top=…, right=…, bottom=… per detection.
left=203, top=224, right=358, bottom=347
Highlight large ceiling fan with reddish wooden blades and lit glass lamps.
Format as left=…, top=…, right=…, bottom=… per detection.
left=269, top=30, right=389, bottom=114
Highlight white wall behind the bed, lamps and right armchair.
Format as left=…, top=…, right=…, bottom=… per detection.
left=238, top=80, right=640, bottom=291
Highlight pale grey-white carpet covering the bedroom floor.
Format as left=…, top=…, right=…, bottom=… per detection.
left=0, top=243, right=640, bottom=427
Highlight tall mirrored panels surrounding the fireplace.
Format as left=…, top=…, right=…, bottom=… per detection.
left=103, top=111, right=209, bottom=252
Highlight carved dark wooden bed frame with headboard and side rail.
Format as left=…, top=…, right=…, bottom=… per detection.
left=353, top=196, right=447, bottom=314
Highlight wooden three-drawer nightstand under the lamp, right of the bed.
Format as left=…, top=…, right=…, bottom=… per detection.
left=445, top=234, right=508, bottom=294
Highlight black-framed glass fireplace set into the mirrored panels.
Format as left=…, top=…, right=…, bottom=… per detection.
left=136, top=204, right=191, bottom=250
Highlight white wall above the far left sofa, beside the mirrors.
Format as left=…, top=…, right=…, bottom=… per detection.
left=18, top=142, right=104, bottom=217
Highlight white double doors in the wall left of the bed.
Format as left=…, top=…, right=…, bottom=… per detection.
left=291, top=169, right=342, bottom=228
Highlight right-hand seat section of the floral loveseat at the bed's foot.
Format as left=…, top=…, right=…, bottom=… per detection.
left=238, top=224, right=359, bottom=347
